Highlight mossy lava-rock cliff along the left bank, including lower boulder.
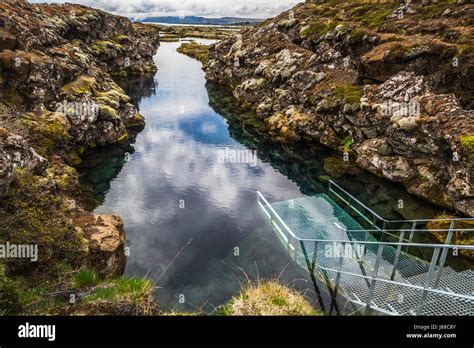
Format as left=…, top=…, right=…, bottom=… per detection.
left=0, top=0, right=159, bottom=277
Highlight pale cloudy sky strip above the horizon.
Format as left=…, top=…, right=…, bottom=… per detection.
left=29, top=0, right=303, bottom=18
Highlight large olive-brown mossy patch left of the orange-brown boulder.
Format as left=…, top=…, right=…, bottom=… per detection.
left=0, top=168, right=82, bottom=268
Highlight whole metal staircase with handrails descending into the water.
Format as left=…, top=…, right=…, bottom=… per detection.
left=257, top=181, right=474, bottom=315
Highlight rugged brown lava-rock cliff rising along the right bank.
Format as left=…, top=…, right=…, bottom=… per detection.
left=205, top=0, right=474, bottom=216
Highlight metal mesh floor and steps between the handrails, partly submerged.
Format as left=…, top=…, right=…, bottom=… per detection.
left=262, top=194, right=474, bottom=315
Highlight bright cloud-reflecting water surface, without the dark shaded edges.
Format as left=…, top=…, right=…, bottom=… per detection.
left=84, top=40, right=322, bottom=312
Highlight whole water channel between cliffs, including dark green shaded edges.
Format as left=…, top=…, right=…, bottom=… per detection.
left=83, top=40, right=452, bottom=313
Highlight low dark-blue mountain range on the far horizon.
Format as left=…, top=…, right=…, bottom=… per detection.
left=136, top=16, right=262, bottom=25
